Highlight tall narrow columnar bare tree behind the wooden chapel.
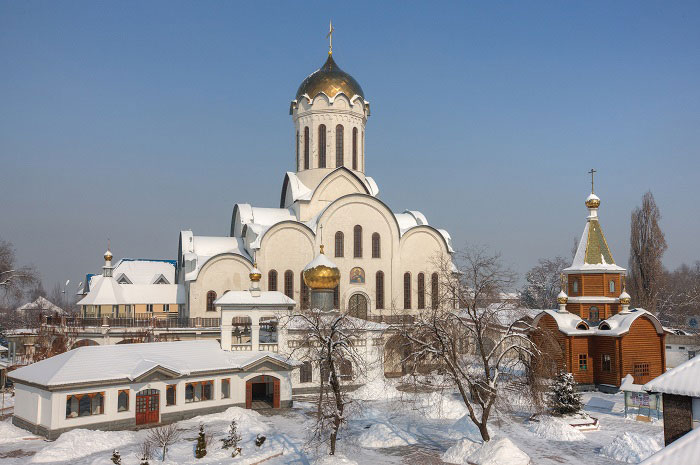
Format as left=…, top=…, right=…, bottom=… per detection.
left=628, top=191, right=668, bottom=312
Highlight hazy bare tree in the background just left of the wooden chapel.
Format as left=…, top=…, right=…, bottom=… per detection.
left=520, top=257, right=568, bottom=309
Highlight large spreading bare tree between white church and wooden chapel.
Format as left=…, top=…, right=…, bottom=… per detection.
left=396, top=248, right=539, bottom=441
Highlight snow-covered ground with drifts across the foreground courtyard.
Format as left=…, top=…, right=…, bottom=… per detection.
left=0, top=382, right=663, bottom=465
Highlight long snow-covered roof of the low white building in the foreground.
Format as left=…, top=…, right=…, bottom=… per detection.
left=10, top=341, right=295, bottom=388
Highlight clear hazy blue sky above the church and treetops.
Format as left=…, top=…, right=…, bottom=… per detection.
left=0, top=0, right=700, bottom=289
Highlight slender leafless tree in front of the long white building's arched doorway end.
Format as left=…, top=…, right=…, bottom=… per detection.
left=283, top=309, right=372, bottom=455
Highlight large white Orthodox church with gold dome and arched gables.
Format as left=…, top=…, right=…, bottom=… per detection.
left=176, top=50, right=452, bottom=319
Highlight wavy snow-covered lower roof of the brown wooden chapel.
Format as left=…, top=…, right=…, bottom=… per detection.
left=533, top=308, right=664, bottom=336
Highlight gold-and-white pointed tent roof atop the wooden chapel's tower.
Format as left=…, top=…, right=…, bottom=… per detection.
left=564, top=216, right=625, bottom=273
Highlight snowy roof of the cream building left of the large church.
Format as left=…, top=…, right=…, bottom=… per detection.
left=78, top=276, right=185, bottom=305
